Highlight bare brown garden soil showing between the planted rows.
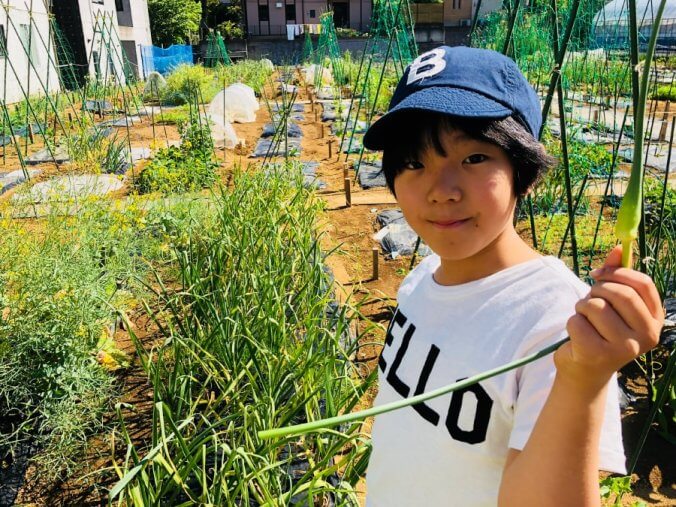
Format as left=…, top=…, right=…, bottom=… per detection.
left=0, top=76, right=676, bottom=506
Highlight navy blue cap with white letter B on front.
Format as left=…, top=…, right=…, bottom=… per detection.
left=364, top=46, right=542, bottom=150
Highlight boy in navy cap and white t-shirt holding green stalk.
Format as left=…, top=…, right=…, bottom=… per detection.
left=364, top=47, right=664, bottom=507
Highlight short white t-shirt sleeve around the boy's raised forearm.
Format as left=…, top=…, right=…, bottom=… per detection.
left=509, top=331, right=626, bottom=474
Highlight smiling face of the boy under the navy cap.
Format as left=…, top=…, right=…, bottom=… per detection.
left=394, top=130, right=516, bottom=276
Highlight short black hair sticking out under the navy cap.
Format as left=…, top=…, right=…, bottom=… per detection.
left=383, top=111, right=556, bottom=198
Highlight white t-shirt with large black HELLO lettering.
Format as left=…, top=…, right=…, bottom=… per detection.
left=366, top=255, right=626, bottom=507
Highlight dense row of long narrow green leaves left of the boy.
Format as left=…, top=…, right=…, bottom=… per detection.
left=111, top=170, right=373, bottom=505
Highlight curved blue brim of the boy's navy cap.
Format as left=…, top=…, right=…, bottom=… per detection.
left=364, top=86, right=513, bottom=150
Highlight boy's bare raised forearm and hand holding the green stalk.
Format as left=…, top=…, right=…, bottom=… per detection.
left=498, top=248, right=664, bottom=507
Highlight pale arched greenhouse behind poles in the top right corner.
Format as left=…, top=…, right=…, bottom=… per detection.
left=593, top=0, right=676, bottom=53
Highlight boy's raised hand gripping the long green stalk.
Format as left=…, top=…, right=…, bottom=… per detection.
left=555, top=246, right=664, bottom=386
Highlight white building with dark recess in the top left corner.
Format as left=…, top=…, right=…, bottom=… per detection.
left=0, top=0, right=152, bottom=103
